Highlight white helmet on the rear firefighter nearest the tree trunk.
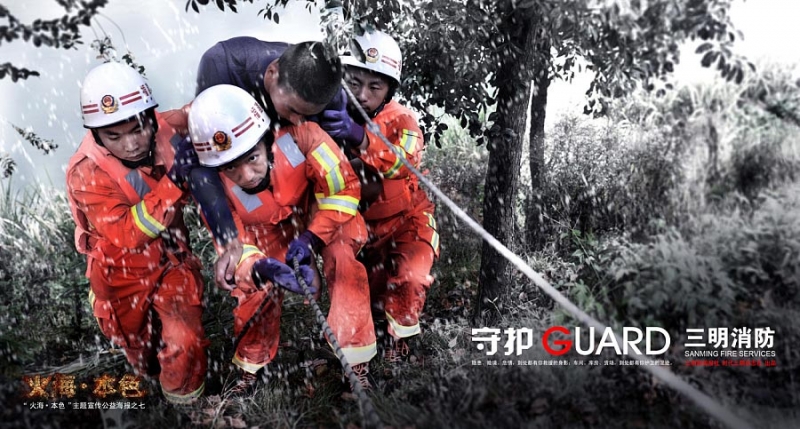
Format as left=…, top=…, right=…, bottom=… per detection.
left=341, top=31, right=403, bottom=84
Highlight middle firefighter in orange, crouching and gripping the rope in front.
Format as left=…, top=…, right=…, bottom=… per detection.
left=189, top=84, right=376, bottom=387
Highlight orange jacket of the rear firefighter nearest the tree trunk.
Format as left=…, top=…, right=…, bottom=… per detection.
left=360, top=100, right=424, bottom=221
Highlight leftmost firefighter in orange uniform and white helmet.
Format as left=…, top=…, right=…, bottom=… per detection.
left=66, top=63, right=208, bottom=404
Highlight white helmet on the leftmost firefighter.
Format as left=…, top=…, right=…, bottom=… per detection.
left=81, top=62, right=158, bottom=128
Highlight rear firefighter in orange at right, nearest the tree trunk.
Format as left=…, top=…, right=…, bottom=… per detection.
left=320, top=31, right=439, bottom=363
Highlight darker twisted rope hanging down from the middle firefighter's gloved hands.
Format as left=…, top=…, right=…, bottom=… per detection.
left=292, top=258, right=383, bottom=429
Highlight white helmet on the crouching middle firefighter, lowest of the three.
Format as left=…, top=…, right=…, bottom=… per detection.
left=189, top=85, right=270, bottom=167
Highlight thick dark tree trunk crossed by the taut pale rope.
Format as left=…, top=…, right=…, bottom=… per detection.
left=473, top=14, right=535, bottom=325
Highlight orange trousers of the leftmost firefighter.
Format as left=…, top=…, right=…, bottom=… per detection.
left=89, top=254, right=208, bottom=403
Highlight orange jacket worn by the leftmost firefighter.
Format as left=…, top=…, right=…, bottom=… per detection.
left=67, top=112, right=188, bottom=277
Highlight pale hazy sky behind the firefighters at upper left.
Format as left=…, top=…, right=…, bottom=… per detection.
left=0, top=0, right=322, bottom=188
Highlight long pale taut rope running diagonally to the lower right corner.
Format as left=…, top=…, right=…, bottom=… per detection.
left=342, top=81, right=753, bottom=429
